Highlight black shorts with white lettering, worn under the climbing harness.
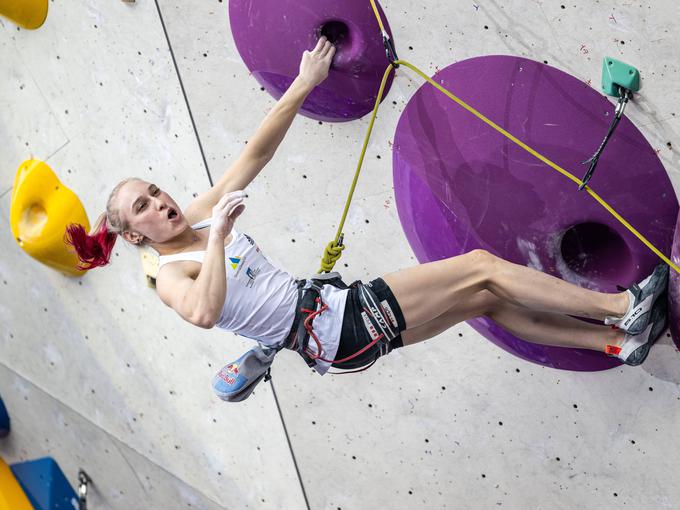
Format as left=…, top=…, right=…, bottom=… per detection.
left=332, top=278, right=406, bottom=370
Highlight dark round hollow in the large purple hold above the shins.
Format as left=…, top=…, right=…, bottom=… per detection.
left=560, top=222, right=631, bottom=284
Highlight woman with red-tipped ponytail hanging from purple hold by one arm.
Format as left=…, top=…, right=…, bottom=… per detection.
left=66, top=37, right=668, bottom=374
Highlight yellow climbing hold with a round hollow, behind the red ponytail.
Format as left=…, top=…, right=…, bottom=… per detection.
left=9, top=159, right=90, bottom=276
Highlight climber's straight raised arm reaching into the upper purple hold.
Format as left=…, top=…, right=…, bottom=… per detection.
left=185, top=36, right=335, bottom=219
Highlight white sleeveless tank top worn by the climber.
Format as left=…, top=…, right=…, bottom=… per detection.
left=158, top=218, right=347, bottom=375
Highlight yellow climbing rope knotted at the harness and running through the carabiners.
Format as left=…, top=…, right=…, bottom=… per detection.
left=320, top=0, right=680, bottom=273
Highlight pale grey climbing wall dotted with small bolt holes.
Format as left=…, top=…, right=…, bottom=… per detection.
left=0, top=0, right=680, bottom=510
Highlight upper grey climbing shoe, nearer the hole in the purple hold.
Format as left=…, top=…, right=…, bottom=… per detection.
left=604, top=264, right=668, bottom=335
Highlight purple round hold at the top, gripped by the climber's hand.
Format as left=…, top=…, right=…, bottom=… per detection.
left=229, top=0, right=392, bottom=122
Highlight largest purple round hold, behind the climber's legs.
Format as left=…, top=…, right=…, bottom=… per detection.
left=393, top=56, right=678, bottom=371
